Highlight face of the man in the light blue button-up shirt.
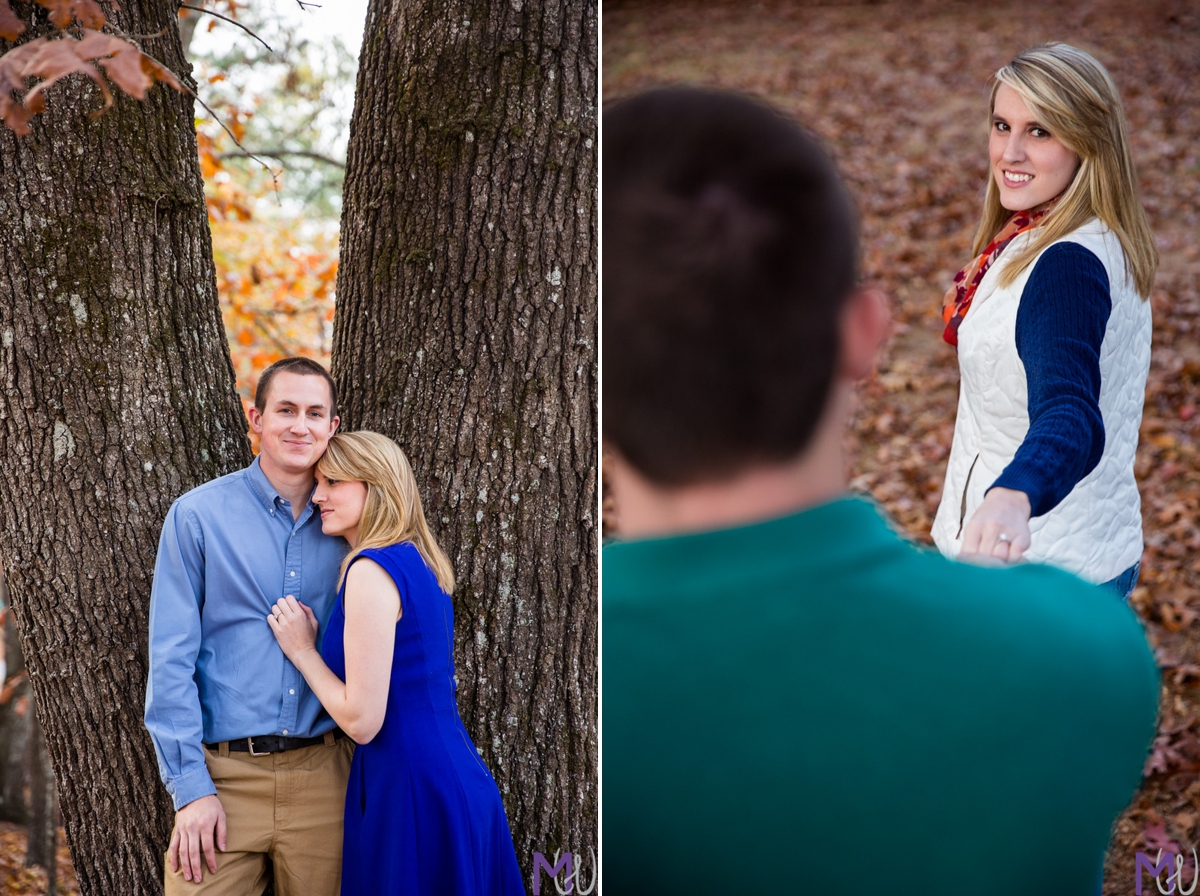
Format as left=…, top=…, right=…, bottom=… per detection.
left=250, top=371, right=338, bottom=474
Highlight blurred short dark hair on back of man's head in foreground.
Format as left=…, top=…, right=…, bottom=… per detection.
left=604, top=88, right=858, bottom=487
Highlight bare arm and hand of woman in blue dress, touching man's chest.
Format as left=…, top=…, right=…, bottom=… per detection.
left=266, top=557, right=401, bottom=744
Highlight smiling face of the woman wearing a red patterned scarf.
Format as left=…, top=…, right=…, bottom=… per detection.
left=988, top=84, right=1079, bottom=211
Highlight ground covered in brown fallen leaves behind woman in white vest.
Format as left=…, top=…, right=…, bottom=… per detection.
left=602, top=0, right=1200, bottom=896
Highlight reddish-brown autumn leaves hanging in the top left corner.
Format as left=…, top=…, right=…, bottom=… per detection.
left=0, top=0, right=184, bottom=134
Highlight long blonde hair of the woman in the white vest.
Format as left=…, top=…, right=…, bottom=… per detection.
left=972, top=42, right=1158, bottom=299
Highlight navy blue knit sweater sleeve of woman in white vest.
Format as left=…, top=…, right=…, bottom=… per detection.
left=990, top=242, right=1112, bottom=517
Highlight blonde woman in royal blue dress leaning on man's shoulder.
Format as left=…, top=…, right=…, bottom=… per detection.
left=268, top=432, right=524, bottom=896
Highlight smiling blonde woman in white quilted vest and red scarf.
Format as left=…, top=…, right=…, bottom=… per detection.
left=932, top=43, right=1158, bottom=597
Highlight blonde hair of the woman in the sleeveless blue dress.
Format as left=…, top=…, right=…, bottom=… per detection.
left=317, top=431, right=454, bottom=594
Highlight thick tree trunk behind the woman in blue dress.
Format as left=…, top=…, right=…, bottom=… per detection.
left=332, top=0, right=598, bottom=879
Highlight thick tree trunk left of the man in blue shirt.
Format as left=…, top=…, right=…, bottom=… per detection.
left=0, top=0, right=251, bottom=896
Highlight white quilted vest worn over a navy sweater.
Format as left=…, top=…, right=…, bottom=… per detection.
left=932, top=218, right=1151, bottom=583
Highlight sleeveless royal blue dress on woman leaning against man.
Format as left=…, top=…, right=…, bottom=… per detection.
left=322, top=542, right=524, bottom=896
